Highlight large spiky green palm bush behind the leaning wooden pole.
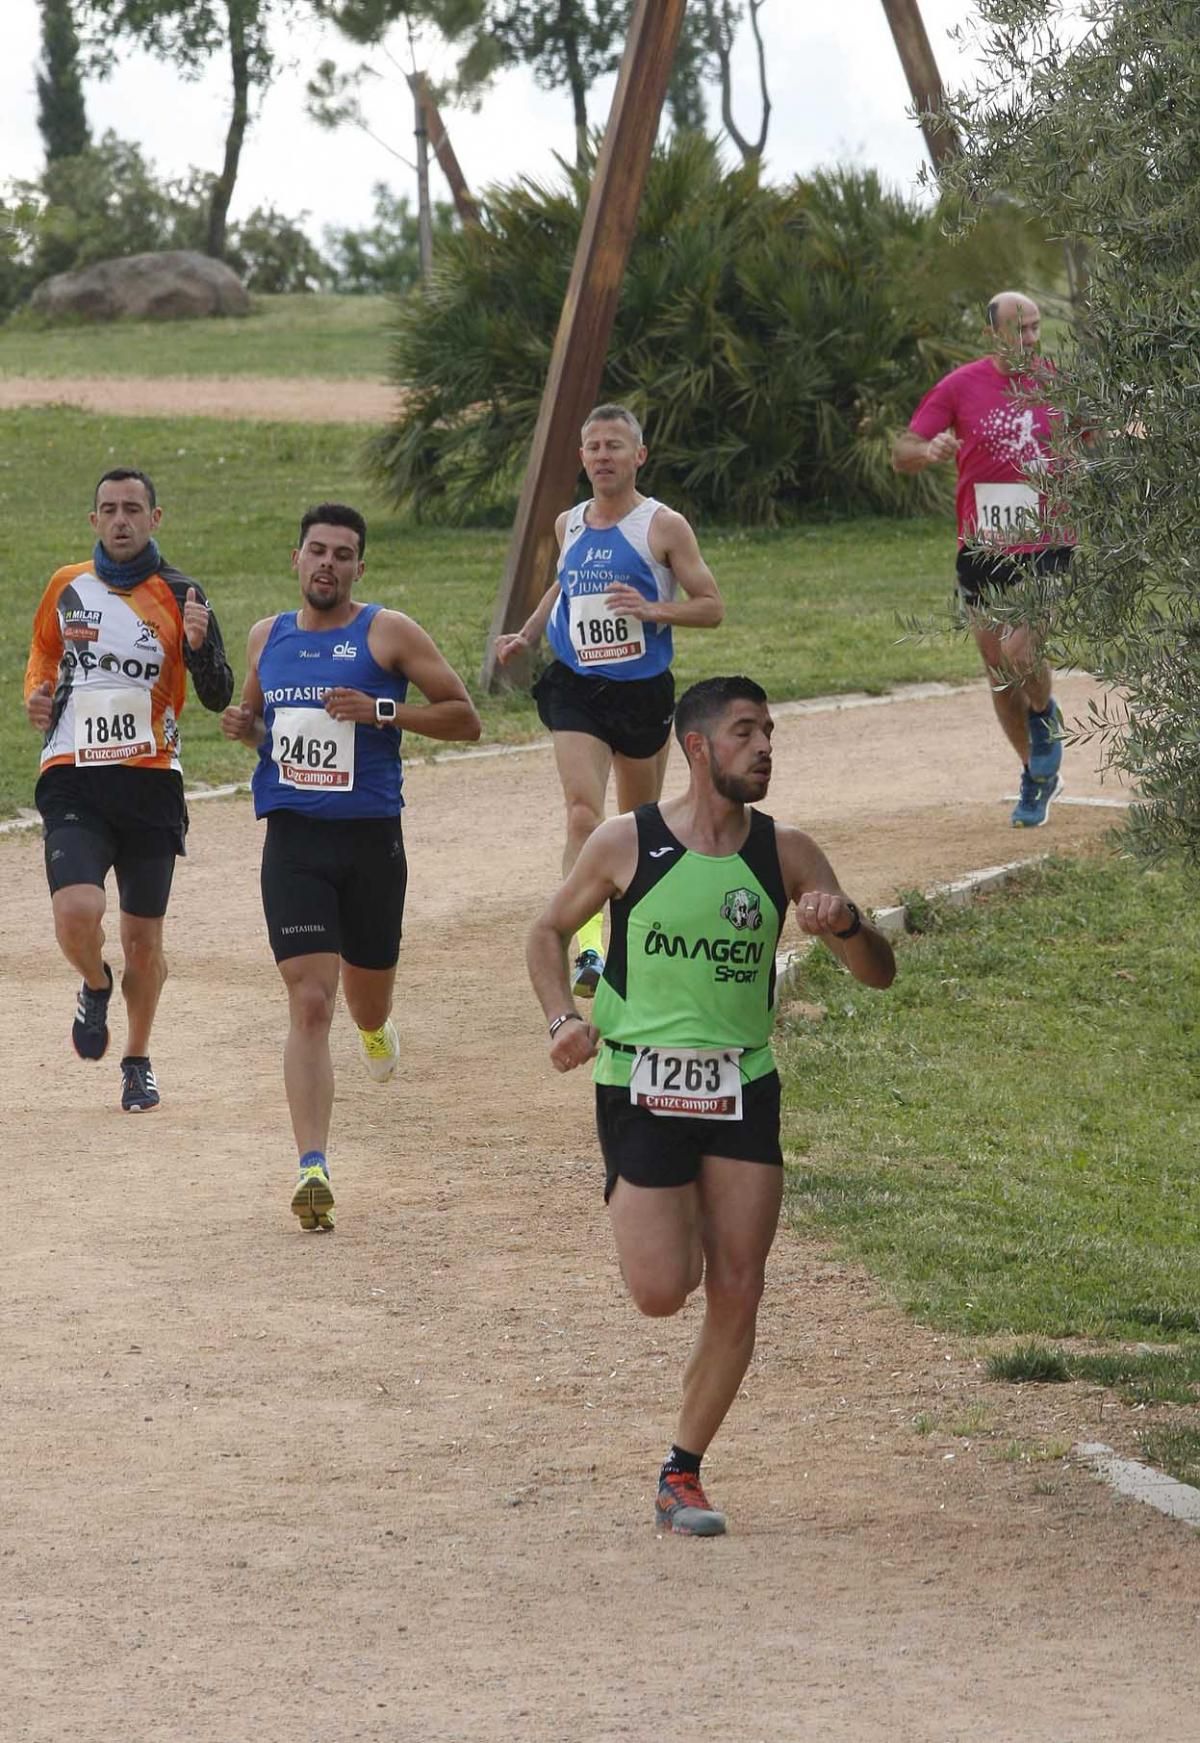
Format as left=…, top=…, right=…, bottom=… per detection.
left=369, top=134, right=1053, bottom=525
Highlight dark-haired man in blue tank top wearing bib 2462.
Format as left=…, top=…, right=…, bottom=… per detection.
left=222, top=502, right=480, bottom=1231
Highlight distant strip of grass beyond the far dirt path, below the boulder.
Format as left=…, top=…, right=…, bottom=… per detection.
left=0, top=296, right=389, bottom=382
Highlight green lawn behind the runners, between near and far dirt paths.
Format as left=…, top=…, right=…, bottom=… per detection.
left=0, top=408, right=977, bottom=814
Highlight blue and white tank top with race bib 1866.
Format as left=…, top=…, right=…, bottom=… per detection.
left=546, top=497, right=675, bottom=682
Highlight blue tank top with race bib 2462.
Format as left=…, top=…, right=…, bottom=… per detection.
left=251, top=605, right=408, bottom=819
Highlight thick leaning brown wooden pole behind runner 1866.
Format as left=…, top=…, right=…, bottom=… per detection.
left=481, top=0, right=685, bottom=688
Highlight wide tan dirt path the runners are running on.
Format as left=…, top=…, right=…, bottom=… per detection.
left=0, top=682, right=1200, bottom=1743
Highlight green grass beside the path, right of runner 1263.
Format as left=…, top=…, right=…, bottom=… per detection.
left=780, top=856, right=1200, bottom=1360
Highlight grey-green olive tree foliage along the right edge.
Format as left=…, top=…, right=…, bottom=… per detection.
left=952, top=0, right=1200, bottom=866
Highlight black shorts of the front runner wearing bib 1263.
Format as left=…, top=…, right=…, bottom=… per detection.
left=597, top=1072, right=783, bottom=1204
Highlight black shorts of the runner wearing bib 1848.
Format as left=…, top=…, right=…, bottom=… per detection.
left=33, top=763, right=187, bottom=920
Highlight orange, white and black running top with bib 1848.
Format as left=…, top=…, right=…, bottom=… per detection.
left=24, top=561, right=234, bottom=770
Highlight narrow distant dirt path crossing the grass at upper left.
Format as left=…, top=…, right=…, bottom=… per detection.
left=0, top=375, right=396, bottom=424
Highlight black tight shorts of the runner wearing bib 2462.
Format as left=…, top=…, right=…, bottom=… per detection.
left=262, top=810, right=408, bottom=969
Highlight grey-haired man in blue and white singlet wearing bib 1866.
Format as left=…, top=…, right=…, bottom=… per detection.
left=495, top=406, right=724, bottom=997
